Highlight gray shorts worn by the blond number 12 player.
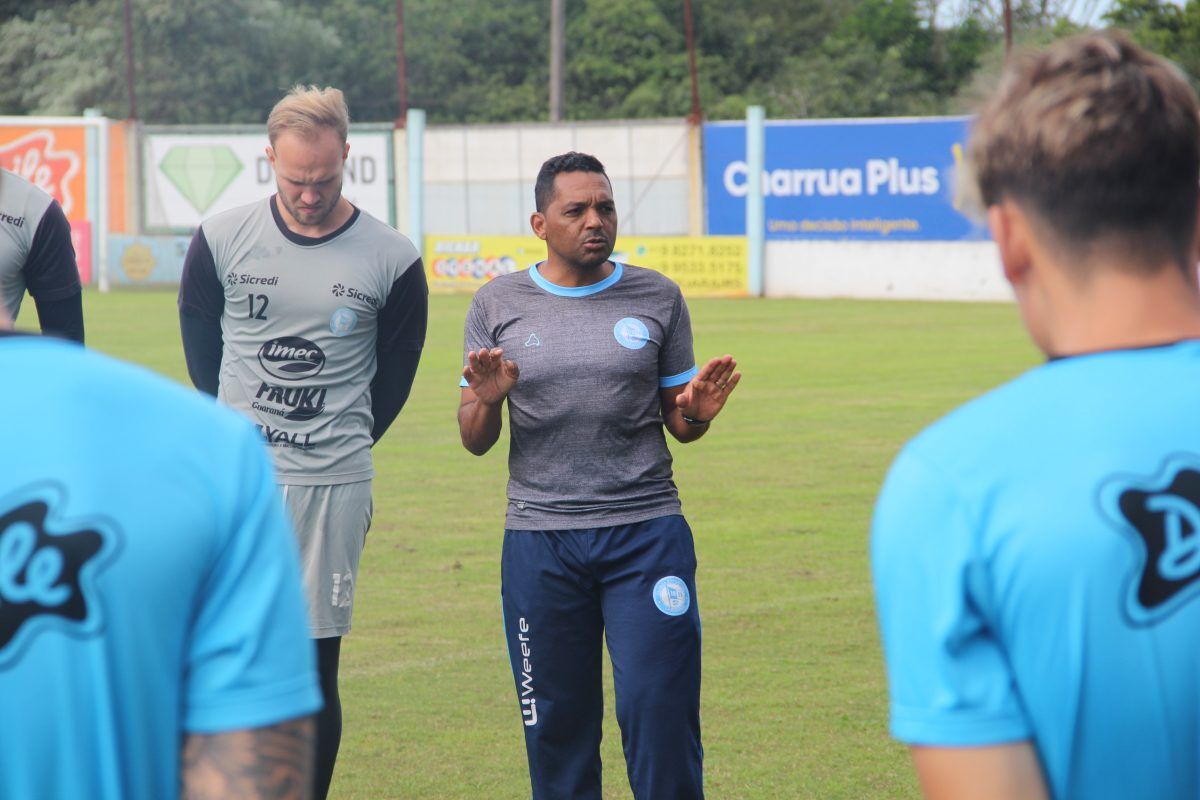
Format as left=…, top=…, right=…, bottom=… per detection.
left=280, top=481, right=374, bottom=639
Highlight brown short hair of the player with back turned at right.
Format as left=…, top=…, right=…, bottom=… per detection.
left=967, top=31, right=1200, bottom=272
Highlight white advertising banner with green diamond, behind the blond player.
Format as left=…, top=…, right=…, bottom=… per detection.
left=143, top=128, right=392, bottom=231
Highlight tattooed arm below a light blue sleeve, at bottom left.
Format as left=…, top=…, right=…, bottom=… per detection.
left=180, top=717, right=313, bottom=800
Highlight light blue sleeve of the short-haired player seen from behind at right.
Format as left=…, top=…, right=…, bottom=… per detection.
left=871, top=450, right=1031, bottom=746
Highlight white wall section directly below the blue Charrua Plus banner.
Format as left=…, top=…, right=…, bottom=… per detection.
left=763, top=239, right=1013, bottom=301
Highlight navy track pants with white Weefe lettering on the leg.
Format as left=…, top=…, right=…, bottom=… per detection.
left=500, top=515, right=704, bottom=800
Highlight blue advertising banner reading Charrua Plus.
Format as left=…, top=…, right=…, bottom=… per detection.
left=704, top=118, right=988, bottom=241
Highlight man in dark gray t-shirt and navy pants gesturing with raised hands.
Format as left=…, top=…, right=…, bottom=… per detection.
left=458, top=152, right=740, bottom=800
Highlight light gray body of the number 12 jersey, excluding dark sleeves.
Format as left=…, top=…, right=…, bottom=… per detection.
left=200, top=200, right=421, bottom=485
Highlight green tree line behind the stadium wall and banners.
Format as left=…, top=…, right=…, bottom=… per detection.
left=0, top=0, right=1200, bottom=124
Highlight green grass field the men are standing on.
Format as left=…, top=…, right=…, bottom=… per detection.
left=42, top=291, right=1037, bottom=800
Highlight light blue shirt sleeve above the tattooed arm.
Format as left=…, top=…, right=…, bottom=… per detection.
left=184, top=427, right=322, bottom=733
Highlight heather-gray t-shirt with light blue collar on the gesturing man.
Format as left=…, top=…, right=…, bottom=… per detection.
left=463, top=264, right=696, bottom=530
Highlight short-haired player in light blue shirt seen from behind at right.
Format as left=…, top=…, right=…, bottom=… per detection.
left=871, top=34, right=1200, bottom=800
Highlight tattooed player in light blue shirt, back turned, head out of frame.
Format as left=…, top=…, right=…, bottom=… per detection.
left=0, top=298, right=322, bottom=800
